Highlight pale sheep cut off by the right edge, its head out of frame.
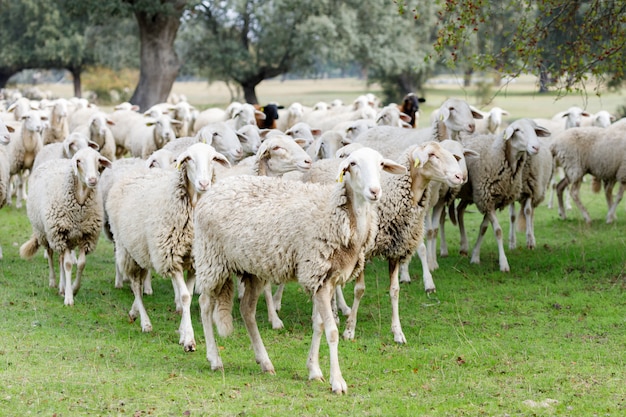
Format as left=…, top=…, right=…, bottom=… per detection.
left=550, top=124, right=626, bottom=224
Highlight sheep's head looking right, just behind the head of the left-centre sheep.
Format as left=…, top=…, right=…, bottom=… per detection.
left=164, top=122, right=244, bottom=164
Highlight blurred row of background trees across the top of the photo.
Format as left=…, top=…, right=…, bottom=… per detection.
left=0, top=0, right=626, bottom=108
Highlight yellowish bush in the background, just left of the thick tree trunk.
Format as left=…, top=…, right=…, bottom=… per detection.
left=83, top=67, right=139, bottom=105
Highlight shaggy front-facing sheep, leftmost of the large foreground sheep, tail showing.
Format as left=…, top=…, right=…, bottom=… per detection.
left=20, top=147, right=111, bottom=306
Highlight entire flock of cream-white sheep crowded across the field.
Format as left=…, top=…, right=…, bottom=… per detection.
left=0, top=88, right=626, bottom=393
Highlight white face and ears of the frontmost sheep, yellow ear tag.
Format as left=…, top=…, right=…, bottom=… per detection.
left=337, top=147, right=406, bottom=203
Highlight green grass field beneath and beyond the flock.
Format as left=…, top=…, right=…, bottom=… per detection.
left=0, top=76, right=626, bottom=417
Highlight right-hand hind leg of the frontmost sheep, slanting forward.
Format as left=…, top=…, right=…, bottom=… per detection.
left=239, top=274, right=276, bottom=374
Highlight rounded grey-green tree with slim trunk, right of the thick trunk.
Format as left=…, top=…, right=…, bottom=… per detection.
left=180, top=0, right=351, bottom=103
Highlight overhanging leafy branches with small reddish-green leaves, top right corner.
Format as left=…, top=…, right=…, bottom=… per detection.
left=414, top=0, right=626, bottom=91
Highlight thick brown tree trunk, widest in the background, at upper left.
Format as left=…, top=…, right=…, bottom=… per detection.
left=130, top=0, right=186, bottom=111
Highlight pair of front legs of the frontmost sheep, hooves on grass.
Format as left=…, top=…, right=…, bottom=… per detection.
left=309, top=280, right=348, bottom=394
